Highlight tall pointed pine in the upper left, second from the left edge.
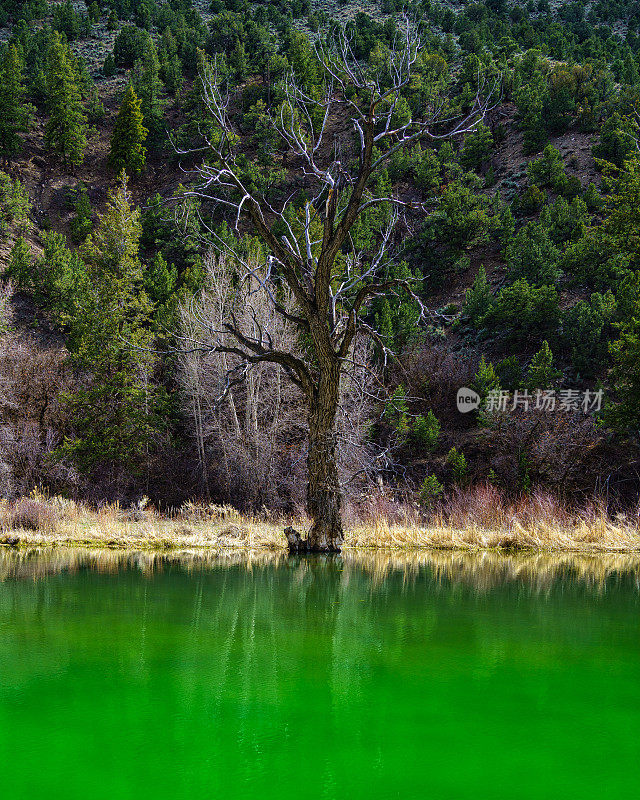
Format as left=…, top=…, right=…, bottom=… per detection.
left=45, top=32, right=87, bottom=166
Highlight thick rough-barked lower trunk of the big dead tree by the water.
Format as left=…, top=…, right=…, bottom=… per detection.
left=285, top=365, right=344, bottom=553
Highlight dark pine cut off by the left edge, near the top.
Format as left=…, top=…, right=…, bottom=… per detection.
left=0, top=45, right=30, bottom=165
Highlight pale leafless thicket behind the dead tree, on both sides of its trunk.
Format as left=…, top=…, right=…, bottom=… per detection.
left=179, top=253, right=370, bottom=509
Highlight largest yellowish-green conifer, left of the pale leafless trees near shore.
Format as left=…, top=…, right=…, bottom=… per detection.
left=59, top=172, right=163, bottom=487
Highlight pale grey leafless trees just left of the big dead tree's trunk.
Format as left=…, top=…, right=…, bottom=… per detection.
left=179, top=253, right=304, bottom=507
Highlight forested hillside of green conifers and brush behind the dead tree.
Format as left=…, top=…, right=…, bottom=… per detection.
left=0, top=0, right=640, bottom=510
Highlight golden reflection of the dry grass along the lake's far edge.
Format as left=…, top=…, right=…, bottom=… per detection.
left=0, top=547, right=640, bottom=591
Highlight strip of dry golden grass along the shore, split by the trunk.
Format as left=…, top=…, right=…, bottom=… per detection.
left=0, top=486, right=640, bottom=553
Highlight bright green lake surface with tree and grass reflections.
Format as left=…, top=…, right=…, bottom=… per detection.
left=0, top=550, right=640, bottom=800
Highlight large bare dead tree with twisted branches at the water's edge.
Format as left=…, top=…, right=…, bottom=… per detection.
left=180, top=23, right=496, bottom=552
